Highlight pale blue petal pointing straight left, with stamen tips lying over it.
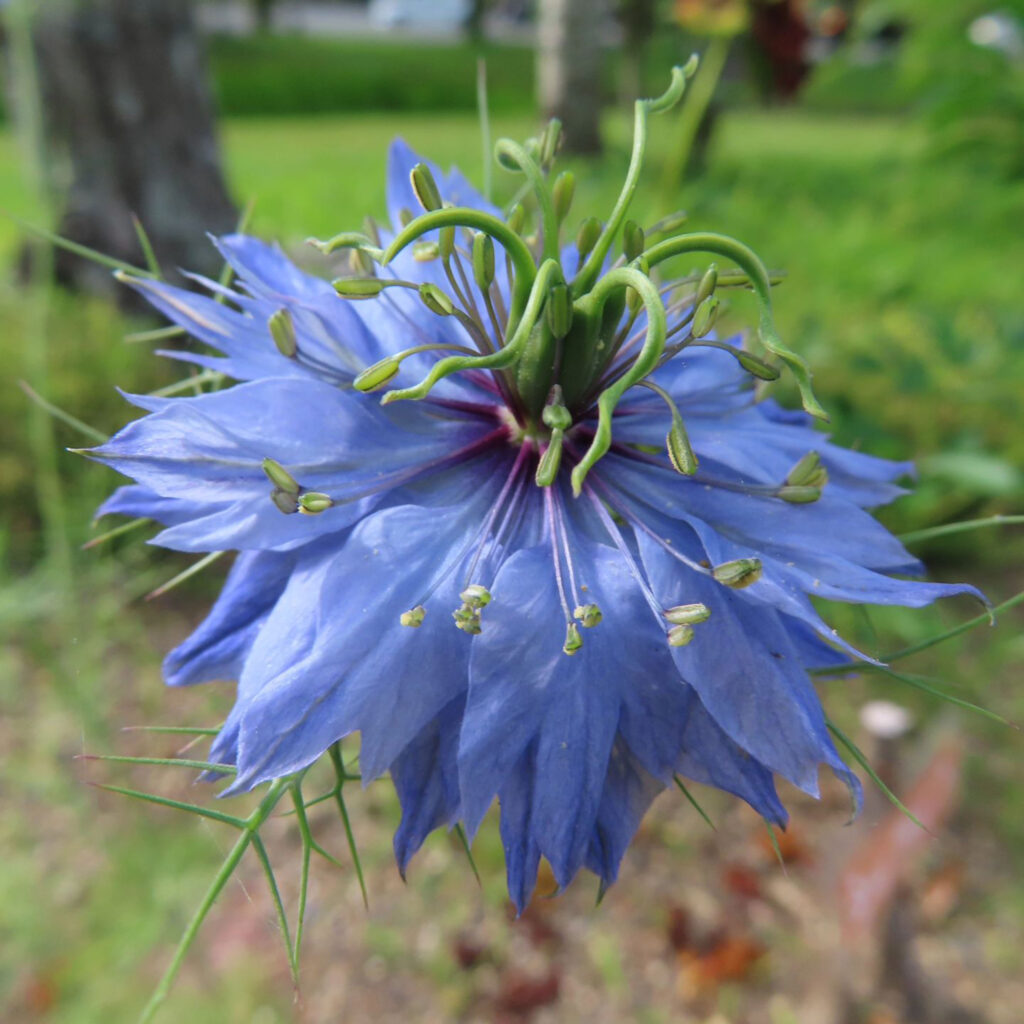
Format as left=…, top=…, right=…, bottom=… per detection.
left=87, top=380, right=493, bottom=551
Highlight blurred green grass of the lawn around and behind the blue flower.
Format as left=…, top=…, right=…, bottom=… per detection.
left=0, top=68, right=1024, bottom=1024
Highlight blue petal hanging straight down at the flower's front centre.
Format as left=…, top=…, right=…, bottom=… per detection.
left=459, top=539, right=674, bottom=886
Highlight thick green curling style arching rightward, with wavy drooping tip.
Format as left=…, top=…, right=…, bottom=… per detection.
left=634, top=231, right=828, bottom=422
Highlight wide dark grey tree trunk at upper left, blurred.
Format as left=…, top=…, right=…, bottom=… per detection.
left=27, top=0, right=238, bottom=293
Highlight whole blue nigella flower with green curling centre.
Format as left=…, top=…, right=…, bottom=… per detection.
left=83, top=72, right=970, bottom=908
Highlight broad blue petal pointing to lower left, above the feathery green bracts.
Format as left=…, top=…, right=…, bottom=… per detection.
left=228, top=487, right=507, bottom=788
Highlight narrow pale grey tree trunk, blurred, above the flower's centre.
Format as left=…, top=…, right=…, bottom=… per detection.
left=537, top=0, right=608, bottom=153
